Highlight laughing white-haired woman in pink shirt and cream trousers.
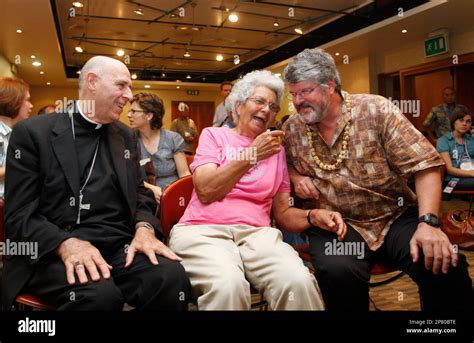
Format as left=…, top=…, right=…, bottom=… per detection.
left=170, top=71, right=346, bottom=310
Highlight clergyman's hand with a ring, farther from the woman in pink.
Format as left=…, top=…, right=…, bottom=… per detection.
left=56, top=238, right=112, bottom=285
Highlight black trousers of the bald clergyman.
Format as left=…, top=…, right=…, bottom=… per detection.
left=26, top=249, right=191, bottom=311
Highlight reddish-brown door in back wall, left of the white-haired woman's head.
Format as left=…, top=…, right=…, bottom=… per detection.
left=171, top=100, right=215, bottom=151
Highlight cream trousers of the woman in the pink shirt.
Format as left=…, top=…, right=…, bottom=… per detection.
left=169, top=224, right=324, bottom=310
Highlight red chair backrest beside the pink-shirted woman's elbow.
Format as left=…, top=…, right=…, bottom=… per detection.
left=160, top=175, right=193, bottom=240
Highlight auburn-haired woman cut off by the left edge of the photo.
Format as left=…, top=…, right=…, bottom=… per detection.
left=0, top=77, right=33, bottom=198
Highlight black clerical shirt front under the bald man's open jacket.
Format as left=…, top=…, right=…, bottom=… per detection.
left=71, top=113, right=133, bottom=251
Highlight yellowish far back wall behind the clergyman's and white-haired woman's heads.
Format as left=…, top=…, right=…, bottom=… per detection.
left=30, top=85, right=222, bottom=128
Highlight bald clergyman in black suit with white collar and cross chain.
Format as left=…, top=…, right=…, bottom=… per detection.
left=3, top=56, right=190, bottom=310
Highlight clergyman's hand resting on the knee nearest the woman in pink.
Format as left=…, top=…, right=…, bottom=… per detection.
left=125, top=227, right=182, bottom=268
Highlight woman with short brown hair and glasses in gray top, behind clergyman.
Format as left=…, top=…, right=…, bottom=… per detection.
left=128, top=93, right=190, bottom=204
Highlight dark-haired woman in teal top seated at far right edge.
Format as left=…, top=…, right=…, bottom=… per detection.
left=436, top=111, right=474, bottom=190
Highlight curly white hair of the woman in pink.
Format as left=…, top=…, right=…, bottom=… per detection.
left=225, top=70, right=285, bottom=118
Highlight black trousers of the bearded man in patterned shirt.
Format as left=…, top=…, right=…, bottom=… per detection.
left=308, top=207, right=474, bottom=311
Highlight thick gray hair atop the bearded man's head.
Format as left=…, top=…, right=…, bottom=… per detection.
left=284, top=48, right=341, bottom=89
